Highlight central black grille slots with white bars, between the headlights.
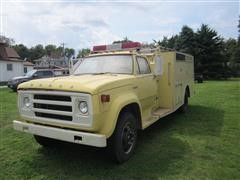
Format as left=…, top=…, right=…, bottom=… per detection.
left=33, top=94, right=73, bottom=121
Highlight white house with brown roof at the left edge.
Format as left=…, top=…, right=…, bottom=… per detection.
left=0, top=43, right=33, bottom=82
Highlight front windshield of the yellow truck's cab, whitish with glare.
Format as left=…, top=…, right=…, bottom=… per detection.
left=73, top=55, right=133, bottom=75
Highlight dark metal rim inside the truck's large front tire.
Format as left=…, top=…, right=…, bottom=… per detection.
left=121, top=122, right=136, bottom=154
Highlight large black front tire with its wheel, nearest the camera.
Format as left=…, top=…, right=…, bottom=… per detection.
left=110, top=112, right=137, bottom=163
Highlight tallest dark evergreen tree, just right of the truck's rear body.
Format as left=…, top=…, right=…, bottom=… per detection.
left=195, top=24, right=229, bottom=79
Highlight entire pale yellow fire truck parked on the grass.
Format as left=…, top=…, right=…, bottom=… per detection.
left=13, top=42, right=194, bottom=163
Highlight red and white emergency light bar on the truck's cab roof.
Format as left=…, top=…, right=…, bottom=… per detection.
left=93, top=42, right=141, bottom=52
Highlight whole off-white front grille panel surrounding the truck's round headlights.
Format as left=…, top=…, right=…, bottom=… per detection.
left=18, top=90, right=93, bottom=128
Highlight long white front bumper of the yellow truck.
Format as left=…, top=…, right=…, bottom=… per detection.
left=13, top=120, right=107, bottom=147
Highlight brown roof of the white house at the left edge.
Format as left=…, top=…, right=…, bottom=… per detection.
left=0, top=43, right=23, bottom=61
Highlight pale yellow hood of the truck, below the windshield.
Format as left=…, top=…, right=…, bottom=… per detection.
left=18, top=74, right=133, bottom=94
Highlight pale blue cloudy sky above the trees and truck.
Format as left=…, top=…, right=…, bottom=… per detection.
left=0, top=0, right=240, bottom=49
